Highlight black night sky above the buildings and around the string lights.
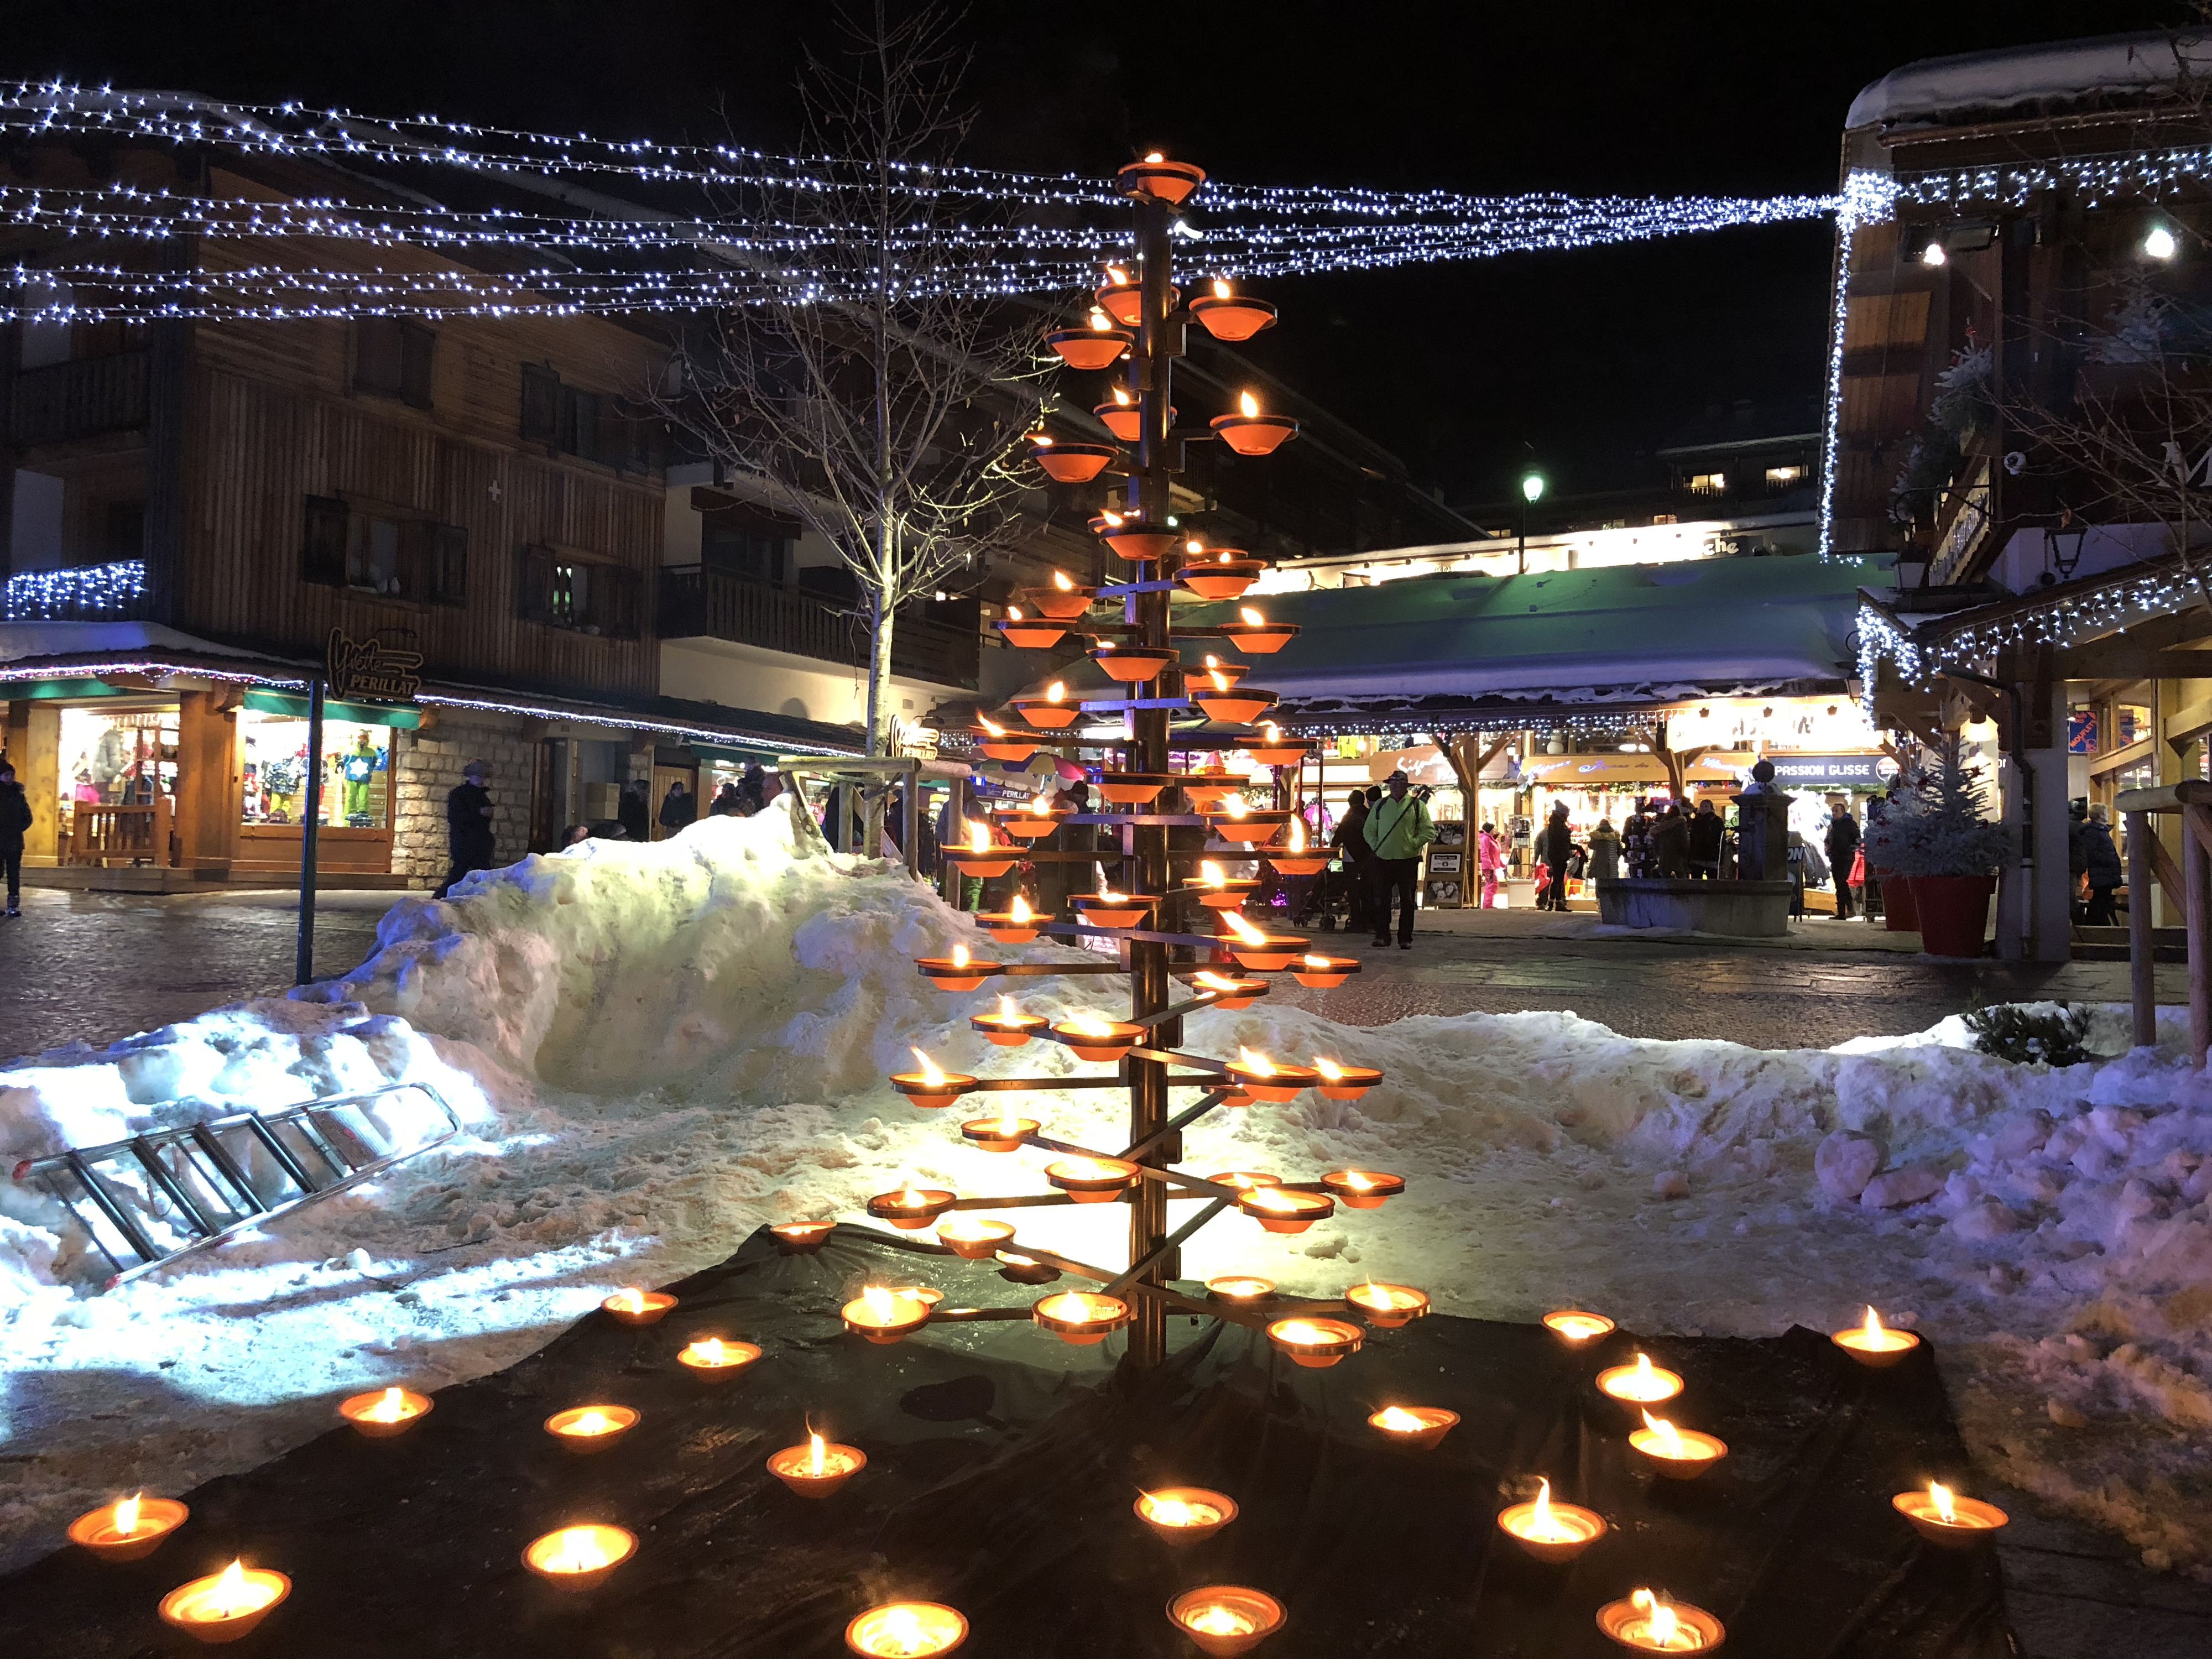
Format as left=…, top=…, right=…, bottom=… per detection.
left=0, top=0, right=2185, bottom=500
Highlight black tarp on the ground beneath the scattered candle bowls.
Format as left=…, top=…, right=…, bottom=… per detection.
left=0, top=1230, right=2006, bottom=1659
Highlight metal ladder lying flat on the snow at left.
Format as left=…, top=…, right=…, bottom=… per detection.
left=15, top=1084, right=460, bottom=1287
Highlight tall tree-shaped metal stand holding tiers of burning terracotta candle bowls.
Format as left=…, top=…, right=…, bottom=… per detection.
left=847, top=155, right=1427, bottom=1367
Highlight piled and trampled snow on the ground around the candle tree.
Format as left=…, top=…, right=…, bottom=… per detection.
left=0, top=812, right=2212, bottom=1575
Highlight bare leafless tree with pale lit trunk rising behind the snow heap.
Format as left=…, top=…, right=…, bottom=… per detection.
left=661, top=0, right=1040, bottom=765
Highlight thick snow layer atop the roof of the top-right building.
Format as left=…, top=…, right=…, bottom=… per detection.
left=1843, top=29, right=2212, bottom=131
